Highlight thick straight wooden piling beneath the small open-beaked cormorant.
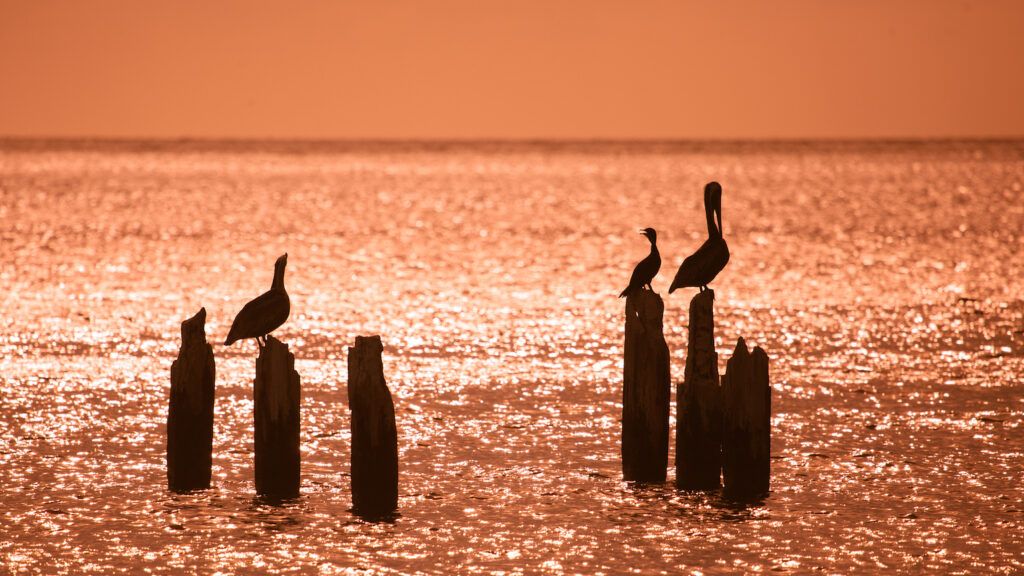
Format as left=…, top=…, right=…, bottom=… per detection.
left=623, top=289, right=672, bottom=482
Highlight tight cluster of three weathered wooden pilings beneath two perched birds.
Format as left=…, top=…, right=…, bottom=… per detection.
left=623, top=290, right=771, bottom=499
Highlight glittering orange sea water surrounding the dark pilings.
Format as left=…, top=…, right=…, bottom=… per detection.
left=0, top=141, right=1024, bottom=574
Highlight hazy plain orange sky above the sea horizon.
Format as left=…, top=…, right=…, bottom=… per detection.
left=0, top=0, right=1024, bottom=138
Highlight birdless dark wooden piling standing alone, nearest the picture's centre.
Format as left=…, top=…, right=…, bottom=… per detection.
left=348, top=336, right=398, bottom=518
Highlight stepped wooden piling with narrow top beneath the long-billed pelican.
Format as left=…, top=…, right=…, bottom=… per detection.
left=676, top=290, right=722, bottom=490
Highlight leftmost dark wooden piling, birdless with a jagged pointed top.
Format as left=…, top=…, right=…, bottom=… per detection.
left=167, top=308, right=216, bottom=492
